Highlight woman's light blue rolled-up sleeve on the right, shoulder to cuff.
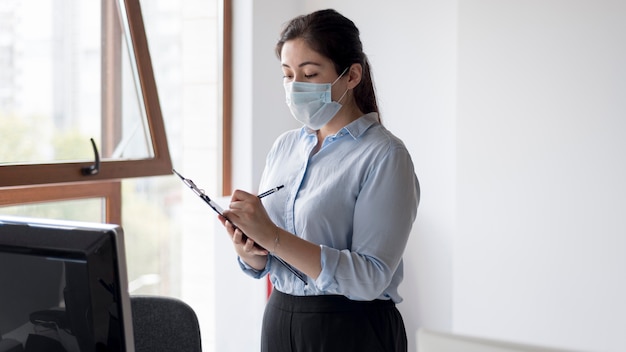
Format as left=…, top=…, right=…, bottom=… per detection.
left=316, top=144, right=419, bottom=302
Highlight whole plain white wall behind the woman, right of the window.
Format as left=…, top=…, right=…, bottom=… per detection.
left=229, top=0, right=626, bottom=351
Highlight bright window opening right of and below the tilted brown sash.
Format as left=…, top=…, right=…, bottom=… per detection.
left=122, top=0, right=221, bottom=351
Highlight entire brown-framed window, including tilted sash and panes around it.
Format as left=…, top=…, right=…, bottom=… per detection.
left=0, top=0, right=230, bottom=351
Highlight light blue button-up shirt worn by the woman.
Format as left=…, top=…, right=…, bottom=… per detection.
left=239, top=113, right=420, bottom=303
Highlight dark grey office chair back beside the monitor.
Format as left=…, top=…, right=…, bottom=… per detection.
left=130, top=296, right=202, bottom=352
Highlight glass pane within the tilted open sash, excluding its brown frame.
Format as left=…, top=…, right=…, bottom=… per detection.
left=0, top=0, right=154, bottom=165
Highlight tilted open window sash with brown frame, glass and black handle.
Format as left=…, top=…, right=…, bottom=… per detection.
left=0, top=0, right=171, bottom=186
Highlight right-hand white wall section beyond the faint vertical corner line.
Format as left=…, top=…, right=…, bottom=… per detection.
left=453, top=0, right=626, bottom=351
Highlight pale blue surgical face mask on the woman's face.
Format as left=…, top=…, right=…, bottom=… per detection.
left=285, top=68, right=348, bottom=130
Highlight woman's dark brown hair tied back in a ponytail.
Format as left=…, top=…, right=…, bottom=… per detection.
left=276, top=9, right=380, bottom=121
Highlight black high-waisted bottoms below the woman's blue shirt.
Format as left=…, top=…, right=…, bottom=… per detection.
left=261, top=289, right=407, bottom=352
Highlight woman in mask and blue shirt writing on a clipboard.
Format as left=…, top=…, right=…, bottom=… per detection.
left=220, top=10, right=419, bottom=352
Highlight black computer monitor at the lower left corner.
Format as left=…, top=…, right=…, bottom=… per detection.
left=0, top=215, right=134, bottom=352
